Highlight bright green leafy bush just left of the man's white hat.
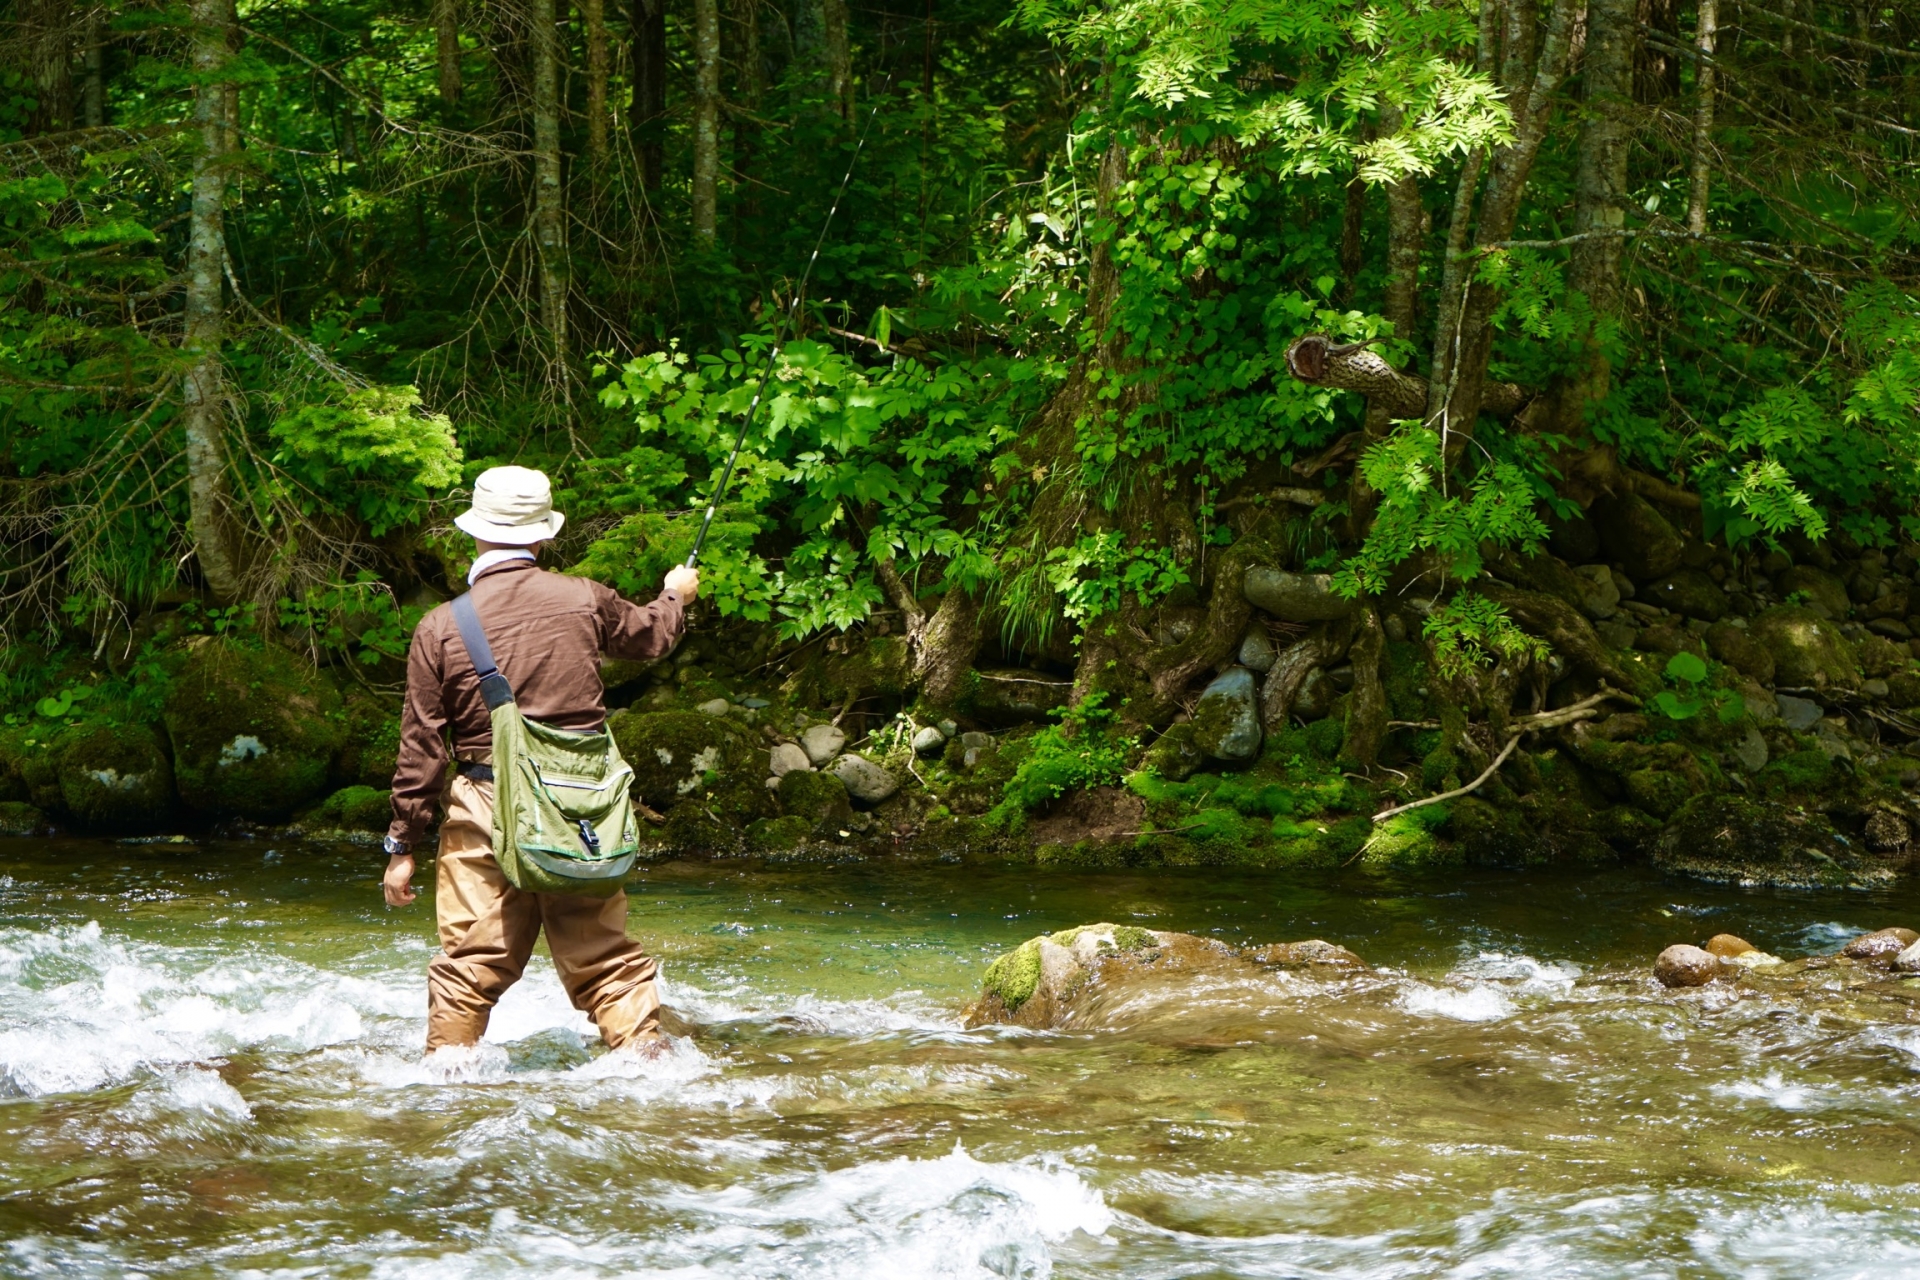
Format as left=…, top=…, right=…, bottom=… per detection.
left=267, top=386, right=461, bottom=537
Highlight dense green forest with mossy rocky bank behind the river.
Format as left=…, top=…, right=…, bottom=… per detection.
left=0, top=0, right=1920, bottom=883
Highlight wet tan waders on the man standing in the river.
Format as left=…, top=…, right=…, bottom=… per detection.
left=426, top=773, right=660, bottom=1052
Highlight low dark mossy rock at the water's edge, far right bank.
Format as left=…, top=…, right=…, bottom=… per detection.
left=1653, top=794, right=1897, bottom=889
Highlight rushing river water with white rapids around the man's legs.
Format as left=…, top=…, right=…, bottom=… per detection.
left=0, top=841, right=1920, bottom=1280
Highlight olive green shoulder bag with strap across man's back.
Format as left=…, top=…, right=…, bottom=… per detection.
left=453, top=593, right=639, bottom=898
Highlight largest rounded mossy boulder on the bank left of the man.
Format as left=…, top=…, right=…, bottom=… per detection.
left=165, top=639, right=348, bottom=819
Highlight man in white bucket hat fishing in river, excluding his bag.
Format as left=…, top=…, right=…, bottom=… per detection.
left=382, top=466, right=699, bottom=1052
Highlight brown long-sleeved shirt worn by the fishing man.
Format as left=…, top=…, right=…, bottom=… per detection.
left=388, top=560, right=685, bottom=848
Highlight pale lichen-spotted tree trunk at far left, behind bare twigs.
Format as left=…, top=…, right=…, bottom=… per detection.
left=180, top=0, right=240, bottom=601
